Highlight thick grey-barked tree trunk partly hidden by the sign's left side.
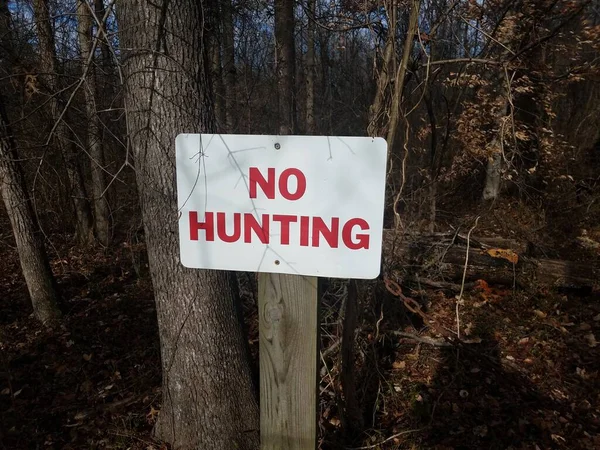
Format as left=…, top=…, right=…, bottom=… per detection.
left=117, top=0, right=258, bottom=450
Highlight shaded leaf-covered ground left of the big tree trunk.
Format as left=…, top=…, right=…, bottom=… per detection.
left=0, top=244, right=160, bottom=450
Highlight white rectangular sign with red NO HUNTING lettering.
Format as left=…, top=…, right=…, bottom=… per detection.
left=175, top=134, right=387, bottom=278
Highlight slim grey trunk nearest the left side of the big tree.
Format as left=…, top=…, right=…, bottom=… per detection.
left=78, top=0, right=110, bottom=246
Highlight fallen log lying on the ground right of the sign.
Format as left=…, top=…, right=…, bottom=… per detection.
left=383, top=230, right=600, bottom=288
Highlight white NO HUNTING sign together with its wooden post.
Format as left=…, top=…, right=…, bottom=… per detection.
left=176, top=134, right=387, bottom=450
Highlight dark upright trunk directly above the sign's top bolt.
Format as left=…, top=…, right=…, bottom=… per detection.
left=275, top=0, right=296, bottom=134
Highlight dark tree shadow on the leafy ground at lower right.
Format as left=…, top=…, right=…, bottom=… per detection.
left=412, top=324, right=573, bottom=450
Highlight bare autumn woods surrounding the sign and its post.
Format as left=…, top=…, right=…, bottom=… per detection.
left=0, top=0, right=600, bottom=449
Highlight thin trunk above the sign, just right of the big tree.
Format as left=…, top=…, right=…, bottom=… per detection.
left=222, top=0, right=237, bottom=133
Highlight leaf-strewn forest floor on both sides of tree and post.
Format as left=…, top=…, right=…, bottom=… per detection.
left=0, top=202, right=600, bottom=450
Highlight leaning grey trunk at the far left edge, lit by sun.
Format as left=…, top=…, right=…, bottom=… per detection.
left=0, top=98, right=60, bottom=325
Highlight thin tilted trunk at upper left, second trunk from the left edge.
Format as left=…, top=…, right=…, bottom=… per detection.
left=33, top=0, right=93, bottom=243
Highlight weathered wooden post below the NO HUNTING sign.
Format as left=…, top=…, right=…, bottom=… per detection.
left=258, top=273, right=319, bottom=450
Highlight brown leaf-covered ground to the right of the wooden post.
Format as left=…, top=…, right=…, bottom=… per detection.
left=321, top=280, right=600, bottom=450
